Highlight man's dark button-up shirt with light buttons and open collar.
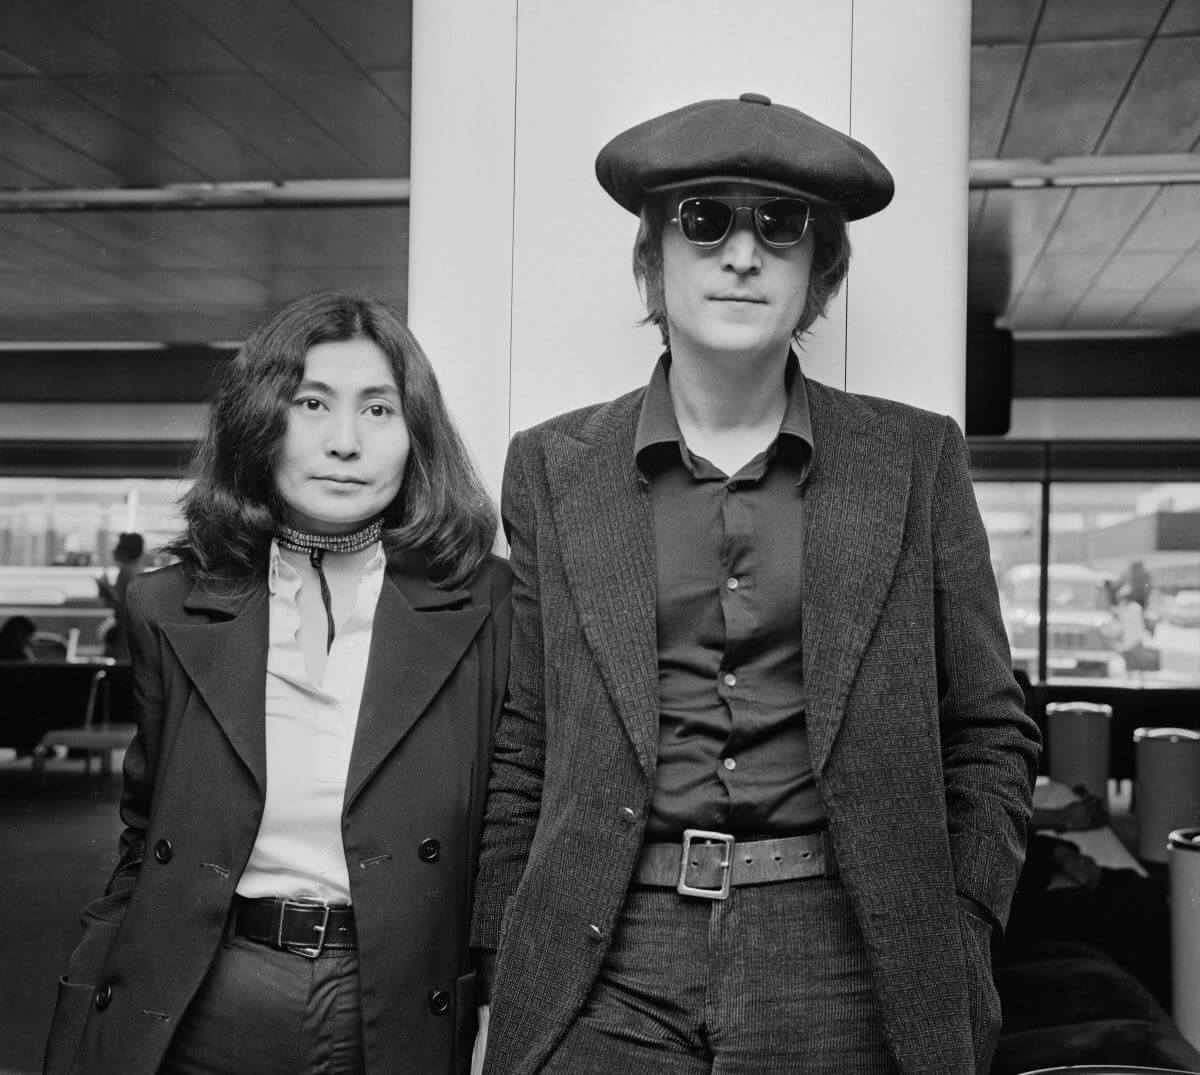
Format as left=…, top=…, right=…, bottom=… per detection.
left=635, top=355, right=826, bottom=840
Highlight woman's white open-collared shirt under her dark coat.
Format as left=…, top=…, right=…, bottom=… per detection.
left=238, top=541, right=386, bottom=903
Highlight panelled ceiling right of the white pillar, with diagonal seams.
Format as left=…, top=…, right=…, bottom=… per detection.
left=968, top=0, right=1200, bottom=334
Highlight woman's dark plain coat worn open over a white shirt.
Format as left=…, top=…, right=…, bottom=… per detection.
left=46, top=554, right=511, bottom=1075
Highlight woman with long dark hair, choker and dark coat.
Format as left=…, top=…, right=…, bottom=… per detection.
left=46, top=293, right=510, bottom=1075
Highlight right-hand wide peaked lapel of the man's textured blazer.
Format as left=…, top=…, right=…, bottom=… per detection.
left=802, top=382, right=911, bottom=773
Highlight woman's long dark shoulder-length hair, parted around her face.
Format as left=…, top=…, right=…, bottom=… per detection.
left=167, top=292, right=497, bottom=589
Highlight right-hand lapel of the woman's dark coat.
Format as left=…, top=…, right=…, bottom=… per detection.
left=344, top=557, right=488, bottom=807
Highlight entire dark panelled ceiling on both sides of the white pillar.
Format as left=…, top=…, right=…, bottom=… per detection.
left=0, top=0, right=1200, bottom=341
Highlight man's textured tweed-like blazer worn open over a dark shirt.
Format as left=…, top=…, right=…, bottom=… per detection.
left=473, top=380, right=1038, bottom=1075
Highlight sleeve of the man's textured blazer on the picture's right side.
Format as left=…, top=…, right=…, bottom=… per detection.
left=932, top=419, right=1040, bottom=926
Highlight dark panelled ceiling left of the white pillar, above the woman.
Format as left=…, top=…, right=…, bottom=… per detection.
left=0, top=0, right=412, bottom=342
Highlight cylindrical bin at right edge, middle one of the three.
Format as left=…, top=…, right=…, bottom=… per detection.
left=1133, top=728, right=1200, bottom=863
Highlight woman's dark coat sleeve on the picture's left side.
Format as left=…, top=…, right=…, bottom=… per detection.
left=43, top=575, right=163, bottom=1073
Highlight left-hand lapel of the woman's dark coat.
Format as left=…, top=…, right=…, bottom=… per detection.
left=162, top=585, right=269, bottom=793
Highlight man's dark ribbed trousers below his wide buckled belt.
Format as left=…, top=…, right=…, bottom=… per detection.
left=542, top=877, right=899, bottom=1075
